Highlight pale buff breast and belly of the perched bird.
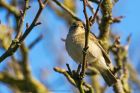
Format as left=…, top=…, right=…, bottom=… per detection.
left=66, top=34, right=102, bottom=63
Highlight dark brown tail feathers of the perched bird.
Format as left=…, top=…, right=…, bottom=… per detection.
left=100, top=69, right=117, bottom=86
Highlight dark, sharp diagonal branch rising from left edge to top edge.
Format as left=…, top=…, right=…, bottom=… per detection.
left=0, top=0, right=48, bottom=63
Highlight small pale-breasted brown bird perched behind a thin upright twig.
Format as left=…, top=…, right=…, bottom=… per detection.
left=65, top=21, right=117, bottom=86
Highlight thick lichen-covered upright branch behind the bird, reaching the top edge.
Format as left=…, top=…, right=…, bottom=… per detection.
left=99, top=0, right=113, bottom=51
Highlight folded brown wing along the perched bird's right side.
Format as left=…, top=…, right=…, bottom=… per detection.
left=89, top=33, right=111, bottom=65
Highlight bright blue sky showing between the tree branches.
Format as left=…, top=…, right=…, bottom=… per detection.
left=0, top=0, right=140, bottom=93
